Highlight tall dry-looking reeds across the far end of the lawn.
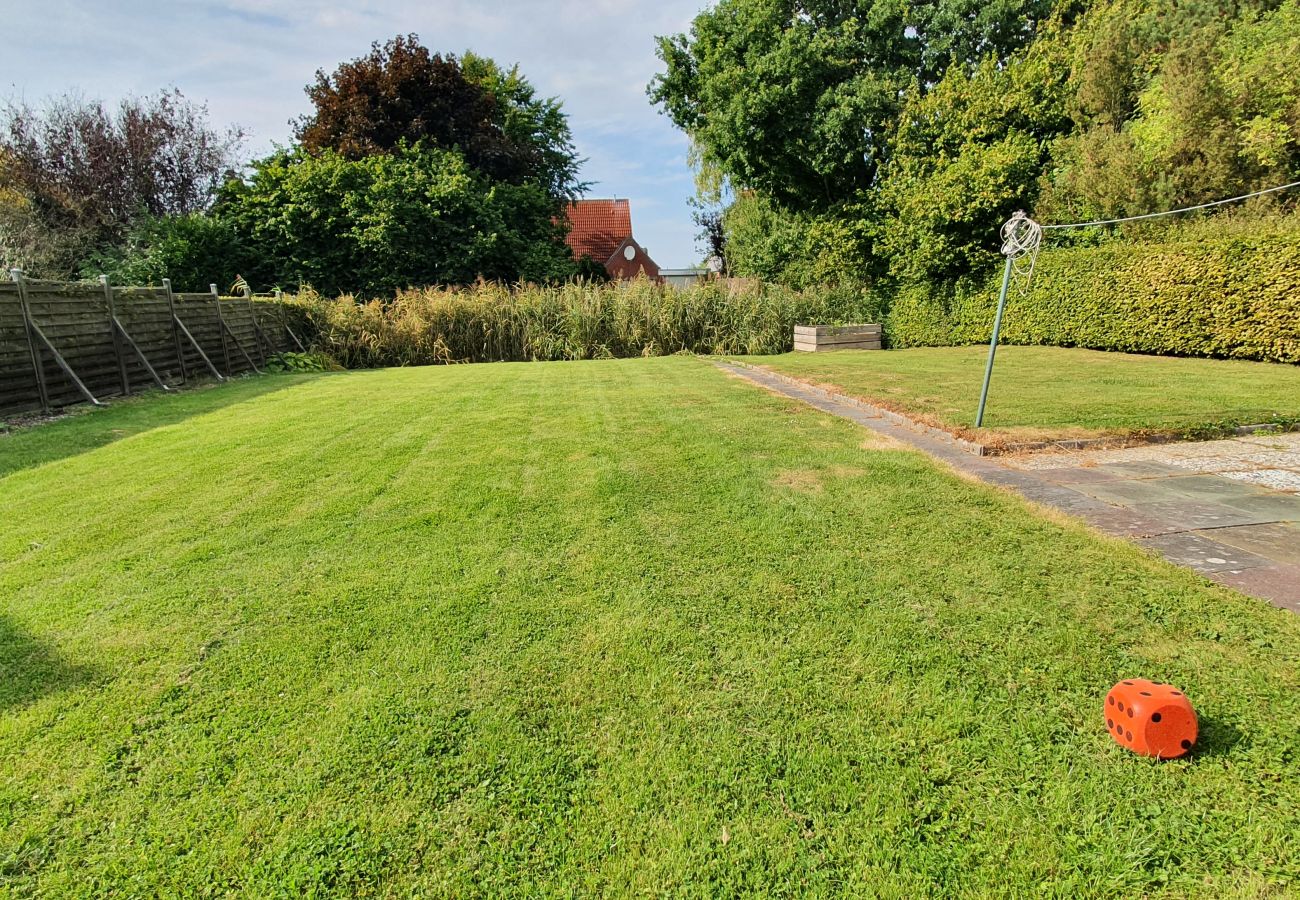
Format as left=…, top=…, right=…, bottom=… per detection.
left=298, top=278, right=879, bottom=368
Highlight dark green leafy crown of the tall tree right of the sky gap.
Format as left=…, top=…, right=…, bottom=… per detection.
left=649, top=0, right=1053, bottom=211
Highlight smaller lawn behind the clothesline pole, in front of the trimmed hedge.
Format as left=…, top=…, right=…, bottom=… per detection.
left=742, top=346, right=1300, bottom=442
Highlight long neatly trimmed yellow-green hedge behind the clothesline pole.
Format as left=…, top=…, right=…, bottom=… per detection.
left=885, top=233, right=1300, bottom=363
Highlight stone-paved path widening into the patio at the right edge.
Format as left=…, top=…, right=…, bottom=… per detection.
left=716, top=362, right=1300, bottom=611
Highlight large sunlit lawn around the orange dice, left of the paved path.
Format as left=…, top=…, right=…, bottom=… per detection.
left=0, top=354, right=1300, bottom=897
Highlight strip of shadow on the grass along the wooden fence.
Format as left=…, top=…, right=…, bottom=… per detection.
left=0, top=375, right=322, bottom=479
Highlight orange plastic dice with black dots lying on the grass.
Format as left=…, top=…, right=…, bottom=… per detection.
left=1104, top=678, right=1197, bottom=760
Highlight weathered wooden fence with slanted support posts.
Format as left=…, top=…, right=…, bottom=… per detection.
left=0, top=272, right=304, bottom=416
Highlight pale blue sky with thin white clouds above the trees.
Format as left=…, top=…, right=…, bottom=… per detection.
left=0, top=0, right=706, bottom=267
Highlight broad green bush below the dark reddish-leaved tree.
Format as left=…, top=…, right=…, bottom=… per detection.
left=215, top=147, right=575, bottom=297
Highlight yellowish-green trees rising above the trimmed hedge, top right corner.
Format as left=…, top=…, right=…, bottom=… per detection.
left=1040, top=0, right=1300, bottom=220
